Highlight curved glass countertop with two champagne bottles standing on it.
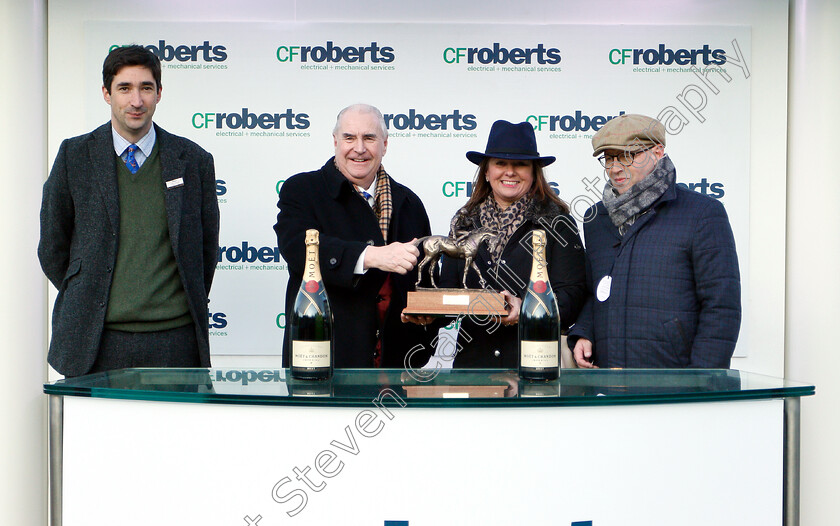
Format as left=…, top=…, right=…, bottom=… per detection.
left=44, top=368, right=815, bottom=407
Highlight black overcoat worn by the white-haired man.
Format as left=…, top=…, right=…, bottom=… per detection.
left=274, top=158, right=431, bottom=367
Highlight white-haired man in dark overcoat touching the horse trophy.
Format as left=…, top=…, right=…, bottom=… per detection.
left=274, top=104, right=431, bottom=367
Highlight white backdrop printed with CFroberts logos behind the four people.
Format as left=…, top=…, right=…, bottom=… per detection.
left=79, top=22, right=751, bottom=355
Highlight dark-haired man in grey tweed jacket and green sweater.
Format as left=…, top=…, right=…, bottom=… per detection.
left=38, top=46, right=219, bottom=376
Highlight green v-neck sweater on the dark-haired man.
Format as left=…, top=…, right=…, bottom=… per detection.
left=105, top=142, right=192, bottom=332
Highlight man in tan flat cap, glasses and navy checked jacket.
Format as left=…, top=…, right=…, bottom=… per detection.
left=569, top=114, right=741, bottom=368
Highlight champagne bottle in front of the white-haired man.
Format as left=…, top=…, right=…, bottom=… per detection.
left=289, top=230, right=333, bottom=380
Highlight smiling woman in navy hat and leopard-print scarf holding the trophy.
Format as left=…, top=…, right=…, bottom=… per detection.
left=406, top=120, right=586, bottom=368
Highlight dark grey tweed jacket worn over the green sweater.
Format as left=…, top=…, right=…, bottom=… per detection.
left=38, top=122, right=219, bottom=376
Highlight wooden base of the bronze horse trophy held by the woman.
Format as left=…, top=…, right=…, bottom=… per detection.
left=403, top=289, right=507, bottom=316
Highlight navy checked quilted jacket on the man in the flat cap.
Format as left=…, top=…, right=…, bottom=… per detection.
left=569, top=171, right=741, bottom=368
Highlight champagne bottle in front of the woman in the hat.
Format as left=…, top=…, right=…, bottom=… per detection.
left=519, top=230, right=560, bottom=380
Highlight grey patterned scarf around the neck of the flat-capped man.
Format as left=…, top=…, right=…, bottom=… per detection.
left=603, top=155, right=677, bottom=235
